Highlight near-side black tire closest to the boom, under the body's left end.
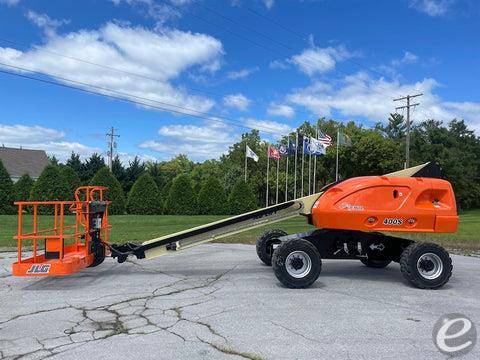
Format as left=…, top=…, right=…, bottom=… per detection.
left=272, top=239, right=322, bottom=289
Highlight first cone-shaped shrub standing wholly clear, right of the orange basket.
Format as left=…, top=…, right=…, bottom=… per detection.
left=127, top=172, right=162, bottom=215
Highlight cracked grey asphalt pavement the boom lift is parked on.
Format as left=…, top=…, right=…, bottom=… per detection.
left=0, top=244, right=480, bottom=360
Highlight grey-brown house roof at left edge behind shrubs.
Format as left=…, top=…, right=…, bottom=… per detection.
left=0, top=147, right=50, bottom=178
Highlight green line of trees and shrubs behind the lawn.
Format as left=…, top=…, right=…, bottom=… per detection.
left=0, top=114, right=480, bottom=215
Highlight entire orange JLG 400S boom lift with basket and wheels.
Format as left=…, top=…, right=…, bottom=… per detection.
left=13, top=163, right=458, bottom=289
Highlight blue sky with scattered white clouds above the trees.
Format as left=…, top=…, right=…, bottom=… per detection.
left=0, top=0, right=480, bottom=163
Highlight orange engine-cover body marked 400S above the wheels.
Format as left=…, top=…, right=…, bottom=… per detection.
left=312, top=176, right=458, bottom=233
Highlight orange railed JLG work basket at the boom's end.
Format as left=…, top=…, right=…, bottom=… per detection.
left=12, top=186, right=110, bottom=276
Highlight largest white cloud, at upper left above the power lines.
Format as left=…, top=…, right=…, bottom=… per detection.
left=0, top=23, right=223, bottom=116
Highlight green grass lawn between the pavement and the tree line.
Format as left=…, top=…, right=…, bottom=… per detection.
left=0, top=210, right=480, bottom=250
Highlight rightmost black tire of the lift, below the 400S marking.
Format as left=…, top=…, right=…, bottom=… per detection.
left=400, top=243, right=453, bottom=289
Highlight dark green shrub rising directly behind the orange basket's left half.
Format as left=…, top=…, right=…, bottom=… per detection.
left=30, top=165, right=70, bottom=214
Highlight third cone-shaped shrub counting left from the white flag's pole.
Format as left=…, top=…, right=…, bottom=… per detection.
left=165, top=174, right=197, bottom=215
